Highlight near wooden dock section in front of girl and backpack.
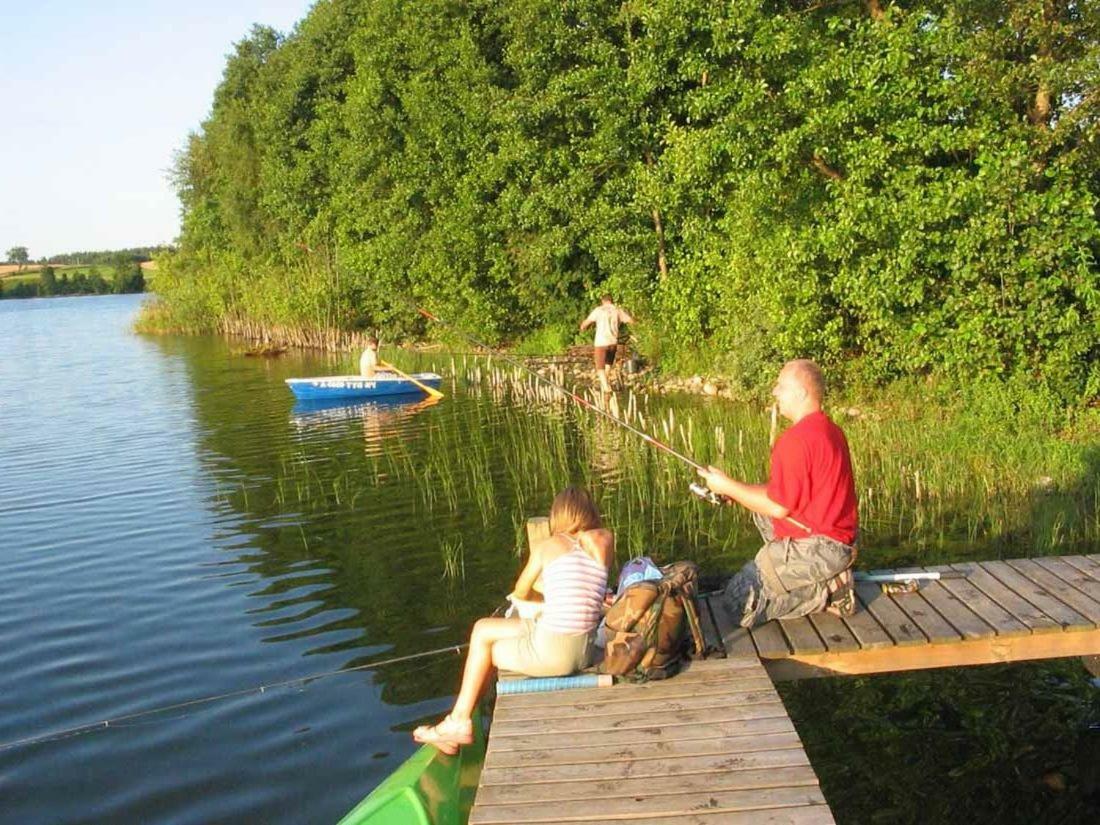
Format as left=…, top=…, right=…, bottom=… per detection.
left=470, top=656, right=833, bottom=825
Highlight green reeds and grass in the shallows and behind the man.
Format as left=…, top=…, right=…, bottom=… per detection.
left=245, top=352, right=1100, bottom=579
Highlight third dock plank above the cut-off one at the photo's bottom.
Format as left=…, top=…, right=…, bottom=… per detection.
left=477, top=746, right=810, bottom=787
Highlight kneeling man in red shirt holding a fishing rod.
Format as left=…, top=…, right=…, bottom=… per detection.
left=700, top=360, right=859, bottom=627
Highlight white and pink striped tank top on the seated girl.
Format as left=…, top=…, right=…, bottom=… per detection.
left=538, top=543, right=607, bottom=634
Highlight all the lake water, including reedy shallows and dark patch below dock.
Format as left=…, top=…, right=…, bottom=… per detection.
left=0, top=296, right=1097, bottom=823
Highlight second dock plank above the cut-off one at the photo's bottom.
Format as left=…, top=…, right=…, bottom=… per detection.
left=477, top=758, right=817, bottom=807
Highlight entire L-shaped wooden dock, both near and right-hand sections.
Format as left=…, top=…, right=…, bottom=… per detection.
left=470, top=556, right=1100, bottom=825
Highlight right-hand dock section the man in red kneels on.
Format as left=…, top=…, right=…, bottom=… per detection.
left=707, top=556, right=1100, bottom=680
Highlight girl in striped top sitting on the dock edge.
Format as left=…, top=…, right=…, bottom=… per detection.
left=413, top=487, right=615, bottom=754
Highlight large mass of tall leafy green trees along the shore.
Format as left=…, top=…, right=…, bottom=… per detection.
left=150, top=0, right=1100, bottom=405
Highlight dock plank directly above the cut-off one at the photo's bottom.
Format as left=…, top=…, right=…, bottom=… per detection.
left=470, top=787, right=825, bottom=825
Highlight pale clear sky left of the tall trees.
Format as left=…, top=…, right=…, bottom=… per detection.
left=0, top=0, right=312, bottom=260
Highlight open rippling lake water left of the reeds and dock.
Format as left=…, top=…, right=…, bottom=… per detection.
left=0, top=296, right=515, bottom=823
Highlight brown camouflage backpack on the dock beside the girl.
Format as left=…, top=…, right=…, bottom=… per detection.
left=600, top=561, right=704, bottom=682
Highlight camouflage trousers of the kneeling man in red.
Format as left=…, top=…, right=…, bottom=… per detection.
left=724, top=514, right=853, bottom=627
